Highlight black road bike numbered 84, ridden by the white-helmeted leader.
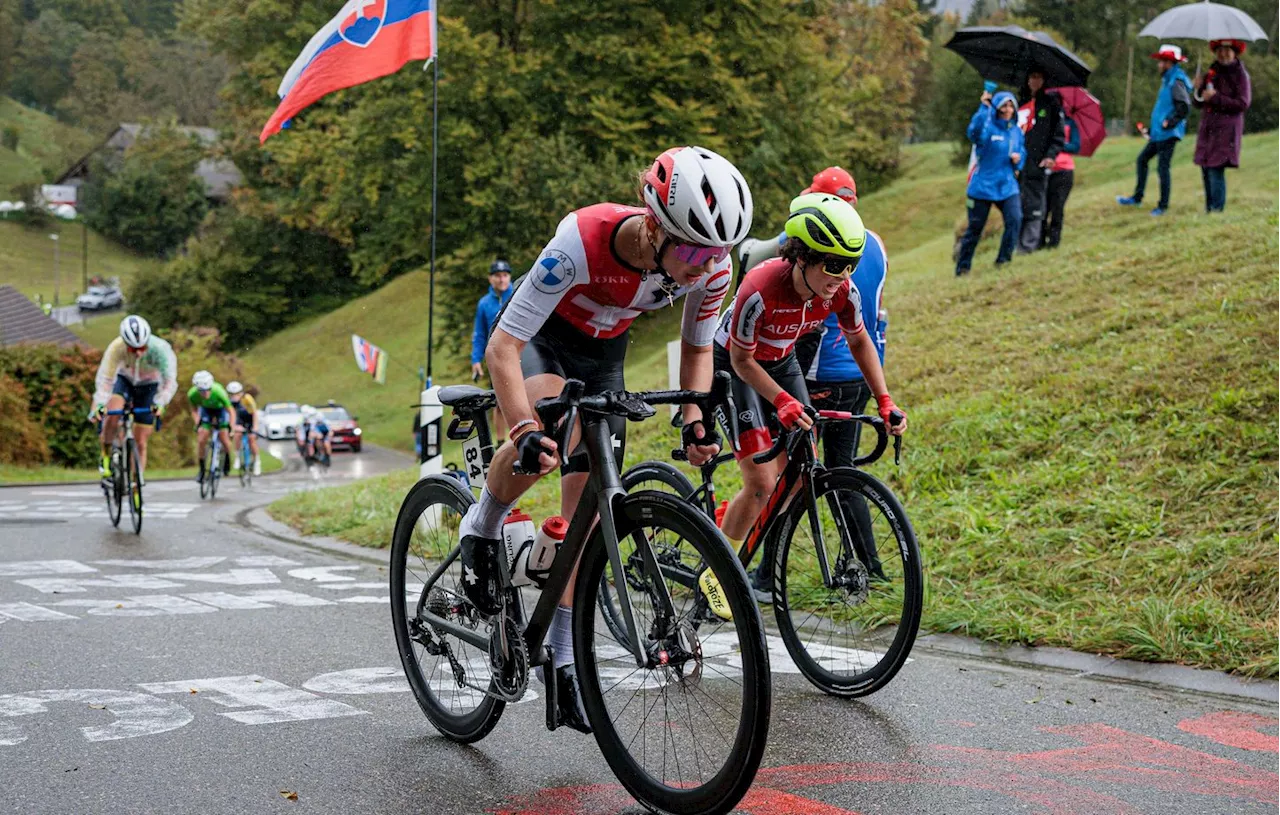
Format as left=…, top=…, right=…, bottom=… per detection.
left=390, top=380, right=772, bottom=815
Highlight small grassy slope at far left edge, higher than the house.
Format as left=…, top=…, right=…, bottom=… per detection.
left=0, top=96, right=95, bottom=191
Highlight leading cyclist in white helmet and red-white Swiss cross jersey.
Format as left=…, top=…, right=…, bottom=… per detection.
left=458, top=147, right=751, bottom=732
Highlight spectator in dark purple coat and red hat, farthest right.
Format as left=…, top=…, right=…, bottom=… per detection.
left=1192, top=40, right=1253, bottom=212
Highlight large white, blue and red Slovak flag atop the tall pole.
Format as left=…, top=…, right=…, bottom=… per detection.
left=259, top=0, right=435, bottom=142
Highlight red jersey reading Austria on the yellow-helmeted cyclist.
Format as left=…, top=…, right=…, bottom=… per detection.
left=716, top=257, right=863, bottom=362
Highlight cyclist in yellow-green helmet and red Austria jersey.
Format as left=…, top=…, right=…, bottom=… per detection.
left=713, top=193, right=906, bottom=598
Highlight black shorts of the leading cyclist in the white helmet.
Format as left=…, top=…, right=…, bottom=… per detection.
left=520, top=313, right=630, bottom=476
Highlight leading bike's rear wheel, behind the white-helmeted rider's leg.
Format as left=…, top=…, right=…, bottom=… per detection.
left=390, top=476, right=506, bottom=743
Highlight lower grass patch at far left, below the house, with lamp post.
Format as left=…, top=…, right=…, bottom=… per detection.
left=0, top=219, right=161, bottom=306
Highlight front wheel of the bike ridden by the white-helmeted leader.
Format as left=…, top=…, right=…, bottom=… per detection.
left=573, top=490, right=772, bottom=815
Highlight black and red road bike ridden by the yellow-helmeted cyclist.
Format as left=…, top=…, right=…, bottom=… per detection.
left=611, top=409, right=924, bottom=697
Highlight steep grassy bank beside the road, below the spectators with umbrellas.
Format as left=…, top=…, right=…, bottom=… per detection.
left=274, top=133, right=1280, bottom=678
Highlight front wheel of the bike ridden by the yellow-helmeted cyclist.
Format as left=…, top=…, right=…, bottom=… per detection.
left=773, top=467, right=924, bottom=699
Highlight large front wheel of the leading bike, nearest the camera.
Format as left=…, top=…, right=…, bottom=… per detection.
left=573, top=490, right=773, bottom=815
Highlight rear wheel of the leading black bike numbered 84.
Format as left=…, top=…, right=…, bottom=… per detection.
left=390, top=475, right=506, bottom=745
